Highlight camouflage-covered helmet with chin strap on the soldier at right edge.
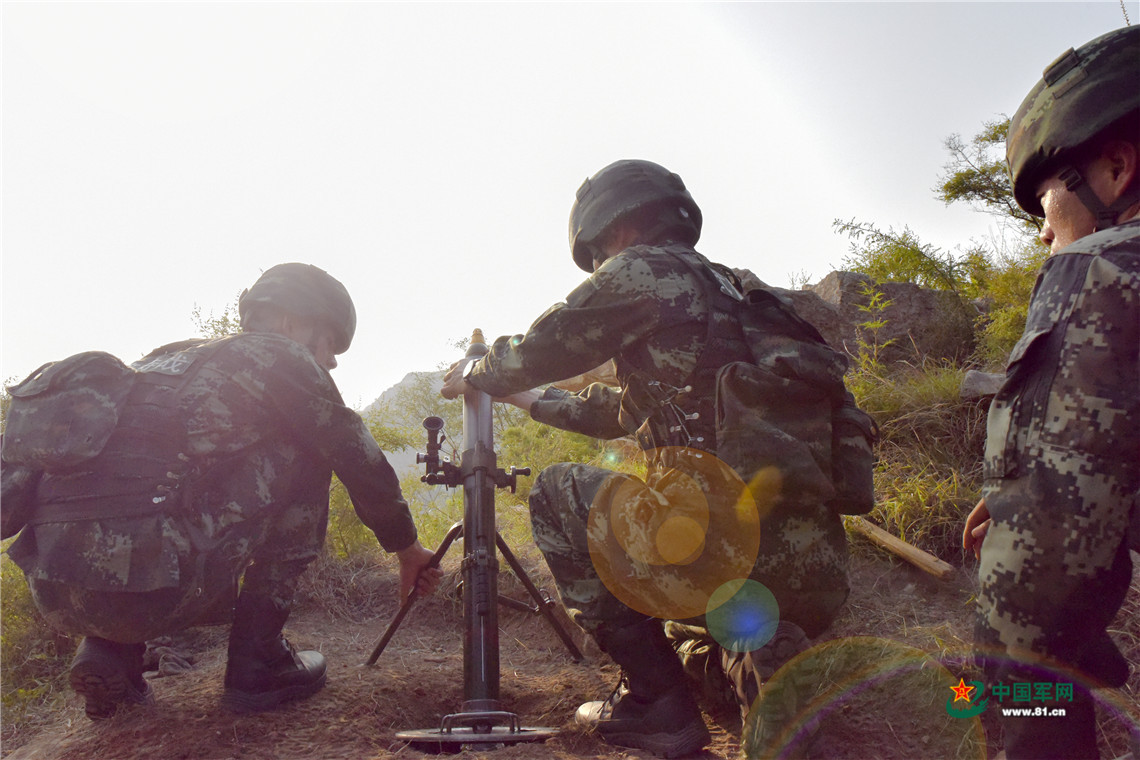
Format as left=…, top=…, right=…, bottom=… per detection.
left=1005, top=26, right=1140, bottom=223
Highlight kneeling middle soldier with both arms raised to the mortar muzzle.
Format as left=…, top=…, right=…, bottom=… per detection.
left=442, top=161, right=848, bottom=757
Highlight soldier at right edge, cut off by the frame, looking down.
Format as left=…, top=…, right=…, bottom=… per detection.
left=963, top=26, right=1140, bottom=760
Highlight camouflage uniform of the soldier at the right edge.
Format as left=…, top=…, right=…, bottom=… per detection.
left=977, top=220, right=1140, bottom=758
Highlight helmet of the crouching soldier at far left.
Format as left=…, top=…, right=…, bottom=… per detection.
left=237, top=263, right=356, bottom=353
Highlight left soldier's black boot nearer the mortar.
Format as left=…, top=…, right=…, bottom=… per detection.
left=221, top=593, right=325, bottom=712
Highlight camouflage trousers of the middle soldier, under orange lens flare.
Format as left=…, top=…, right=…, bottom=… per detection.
left=530, top=463, right=848, bottom=637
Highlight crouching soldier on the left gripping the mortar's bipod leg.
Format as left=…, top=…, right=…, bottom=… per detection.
left=3, top=263, right=439, bottom=719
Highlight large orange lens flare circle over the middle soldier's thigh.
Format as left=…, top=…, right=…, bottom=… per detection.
left=587, top=447, right=760, bottom=620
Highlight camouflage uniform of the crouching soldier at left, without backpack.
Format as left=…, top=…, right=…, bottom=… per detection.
left=9, top=333, right=416, bottom=643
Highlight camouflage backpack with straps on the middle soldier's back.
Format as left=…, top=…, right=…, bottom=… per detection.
left=638, top=246, right=878, bottom=514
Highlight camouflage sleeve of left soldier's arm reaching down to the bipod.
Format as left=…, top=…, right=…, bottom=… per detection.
left=254, top=341, right=416, bottom=551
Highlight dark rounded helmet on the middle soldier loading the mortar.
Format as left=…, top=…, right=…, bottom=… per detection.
left=570, top=158, right=701, bottom=272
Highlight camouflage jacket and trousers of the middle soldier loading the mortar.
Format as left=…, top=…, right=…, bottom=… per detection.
left=467, top=244, right=848, bottom=720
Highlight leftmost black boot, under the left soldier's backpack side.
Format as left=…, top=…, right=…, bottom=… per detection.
left=70, top=636, right=154, bottom=720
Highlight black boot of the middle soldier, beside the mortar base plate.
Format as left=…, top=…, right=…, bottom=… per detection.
left=576, top=620, right=709, bottom=758
